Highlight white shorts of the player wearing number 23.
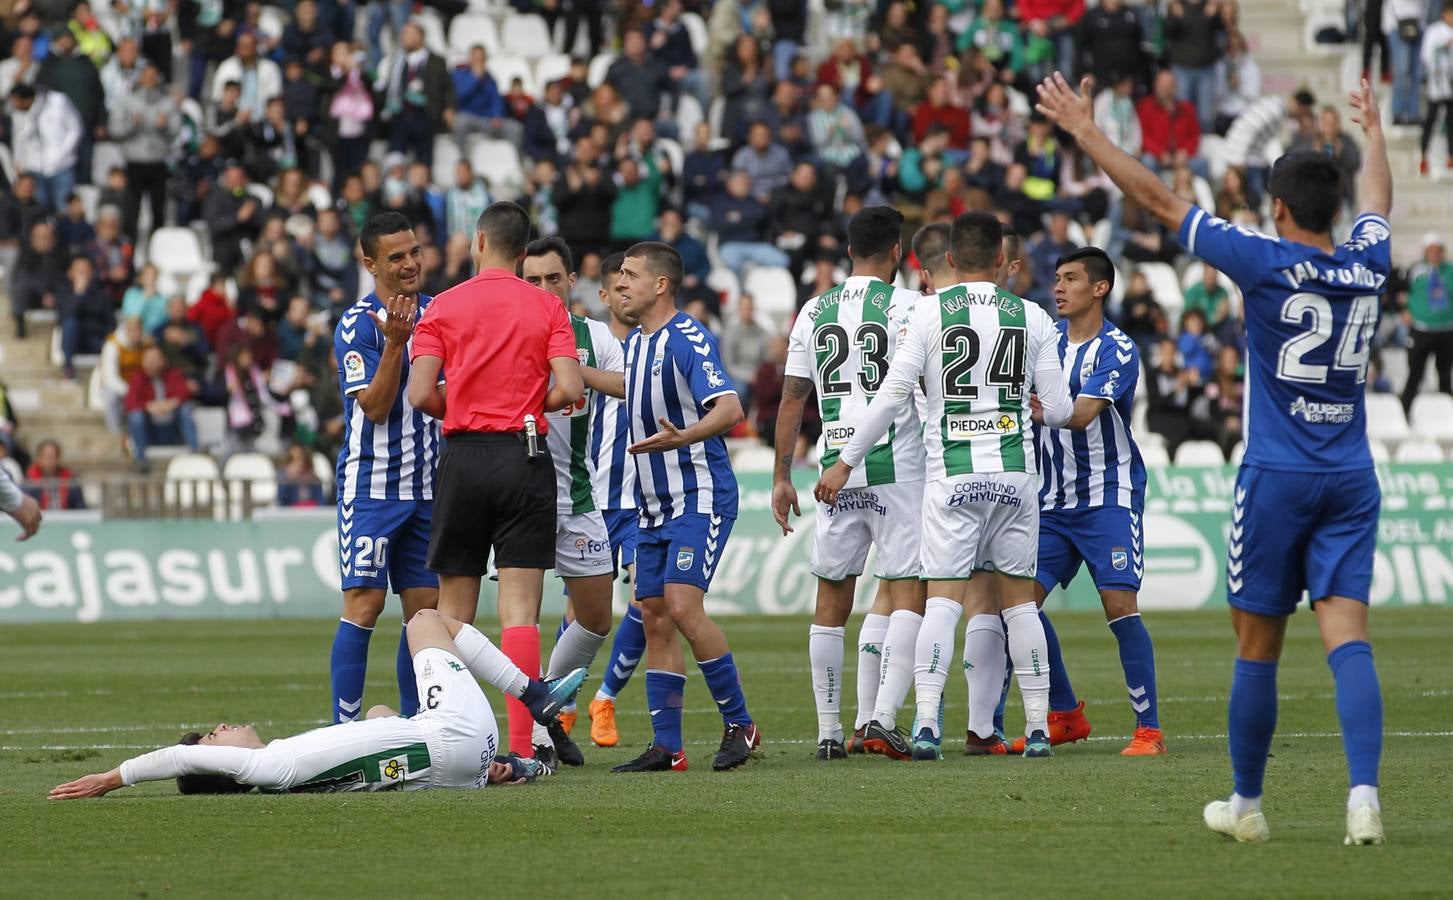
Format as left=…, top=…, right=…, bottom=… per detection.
left=812, top=481, right=923, bottom=582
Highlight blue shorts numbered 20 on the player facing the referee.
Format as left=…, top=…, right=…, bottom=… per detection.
left=339, top=497, right=439, bottom=593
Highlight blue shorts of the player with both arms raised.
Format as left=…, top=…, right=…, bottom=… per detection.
left=1226, top=465, right=1382, bottom=615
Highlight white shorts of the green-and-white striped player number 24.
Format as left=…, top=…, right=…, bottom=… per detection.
left=921, top=473, right=1039, bottom=580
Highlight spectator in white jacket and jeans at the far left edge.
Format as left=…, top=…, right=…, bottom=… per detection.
left=10, top=84, right=83, bottom=209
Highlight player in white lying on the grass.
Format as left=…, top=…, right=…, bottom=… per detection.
left=49, top=609, right=586, bottom=800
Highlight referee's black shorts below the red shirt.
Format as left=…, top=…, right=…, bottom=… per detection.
left=429, top=432, right=555, bottom=576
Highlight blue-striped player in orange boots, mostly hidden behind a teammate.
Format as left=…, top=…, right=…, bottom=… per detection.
left=590, top=253, right=645, bottom=747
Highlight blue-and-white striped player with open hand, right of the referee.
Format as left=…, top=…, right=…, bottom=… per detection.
left=615, top=241, right=761, bottom=772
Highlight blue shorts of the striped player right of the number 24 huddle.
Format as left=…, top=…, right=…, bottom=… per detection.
left=1035, top=506, right=1145, bottom=593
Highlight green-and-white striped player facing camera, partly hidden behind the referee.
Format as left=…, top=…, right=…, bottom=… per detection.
left=520, top=237, right=626, bottom=766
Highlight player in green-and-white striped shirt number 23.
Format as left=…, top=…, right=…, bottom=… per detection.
left=772, top=206, right=924, bottom=760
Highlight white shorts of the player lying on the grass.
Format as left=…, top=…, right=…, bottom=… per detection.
left=408, top=647, right=500, bottom=788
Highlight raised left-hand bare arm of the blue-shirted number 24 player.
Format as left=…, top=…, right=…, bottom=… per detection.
left=1035, top=71, right=1190, bottom=231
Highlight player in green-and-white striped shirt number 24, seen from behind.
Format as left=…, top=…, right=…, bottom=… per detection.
left=817, top=212, right=1072, bottom=759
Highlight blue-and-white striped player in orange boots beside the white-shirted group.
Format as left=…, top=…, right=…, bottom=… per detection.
left=1035, top=247, right=1165, bottom=756
